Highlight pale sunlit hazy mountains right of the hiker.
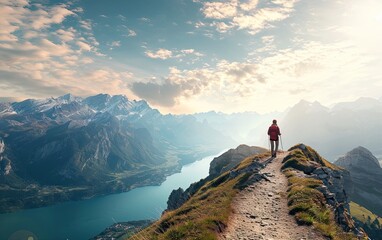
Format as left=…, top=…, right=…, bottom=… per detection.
left=279, top=98, right=382, bottom=161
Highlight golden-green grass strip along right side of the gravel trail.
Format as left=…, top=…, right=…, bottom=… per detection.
left=282, top=146, right=357, bottom=240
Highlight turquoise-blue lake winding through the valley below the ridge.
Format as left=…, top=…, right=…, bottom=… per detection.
left=0, top=151, right=222, bottom=240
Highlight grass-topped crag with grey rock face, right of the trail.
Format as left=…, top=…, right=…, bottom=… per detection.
left=283, top=144, right=364, bottom=235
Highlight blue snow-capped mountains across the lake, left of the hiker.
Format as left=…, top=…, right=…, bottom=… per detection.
left=0, top=94, right=233, bottom=212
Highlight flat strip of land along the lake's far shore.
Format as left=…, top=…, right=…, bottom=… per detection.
left=0, top=150, right=221, bottom=215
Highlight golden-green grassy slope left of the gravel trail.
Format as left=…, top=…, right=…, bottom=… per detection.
left=125, top=154, right=266, bottom=240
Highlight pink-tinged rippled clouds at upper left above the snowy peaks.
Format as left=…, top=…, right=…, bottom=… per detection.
left=0, top=0, right=133, bottom=98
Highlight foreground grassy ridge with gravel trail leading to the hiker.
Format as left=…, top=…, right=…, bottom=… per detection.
left=126, top=144, right=362, bottom=240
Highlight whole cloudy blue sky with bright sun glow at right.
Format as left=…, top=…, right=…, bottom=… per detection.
left=0, top=0, right=382, bottom=114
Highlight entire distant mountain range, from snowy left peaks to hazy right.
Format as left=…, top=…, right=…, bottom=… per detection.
left=0, top=94, right=382, bottom=212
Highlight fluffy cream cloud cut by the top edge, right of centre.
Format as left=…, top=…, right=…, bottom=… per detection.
left=196, top=0, right=298, bottom=35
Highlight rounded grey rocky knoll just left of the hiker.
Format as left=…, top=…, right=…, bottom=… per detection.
left=210, top=144, right=267, bottom=176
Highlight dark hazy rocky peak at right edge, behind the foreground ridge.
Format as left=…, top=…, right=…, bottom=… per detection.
left=335, top=147, right=382, bottom=216
